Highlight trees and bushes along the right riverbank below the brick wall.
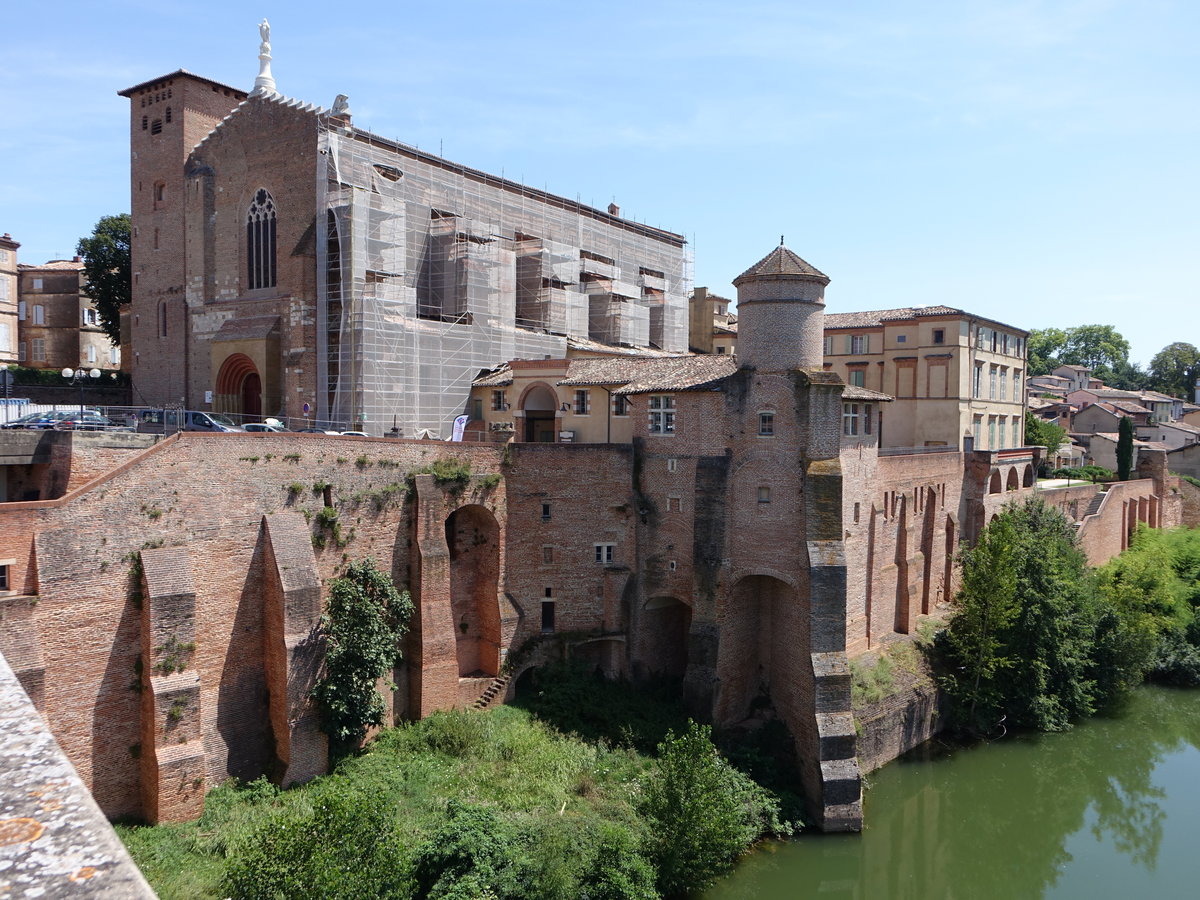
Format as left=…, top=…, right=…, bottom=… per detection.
left=934, top=499, right=1200, bottom=734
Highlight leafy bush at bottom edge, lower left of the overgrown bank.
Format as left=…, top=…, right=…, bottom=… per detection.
left=226, top=780, right=409, bottom=900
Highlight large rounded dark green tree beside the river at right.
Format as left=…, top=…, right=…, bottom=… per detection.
left=937, top=499, right=1099, bottom=733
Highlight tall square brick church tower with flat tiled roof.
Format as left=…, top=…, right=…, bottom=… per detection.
left=119, top=70, right=246, bottom=404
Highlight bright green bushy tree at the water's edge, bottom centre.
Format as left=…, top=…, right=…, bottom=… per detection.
left=638, top=722, right=791, bottom=896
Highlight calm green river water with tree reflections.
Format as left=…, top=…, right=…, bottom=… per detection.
left=702, top=688, right=1200, bottom=900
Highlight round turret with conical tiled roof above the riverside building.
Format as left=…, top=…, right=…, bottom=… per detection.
left=733, top=240, right=829, bottom=372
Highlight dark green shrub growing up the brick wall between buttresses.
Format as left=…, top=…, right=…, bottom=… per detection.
left=313, top=559, right=413, bottom=746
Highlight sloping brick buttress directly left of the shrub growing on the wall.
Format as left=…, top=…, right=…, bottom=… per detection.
left=263, top=512, right=329, bottom=787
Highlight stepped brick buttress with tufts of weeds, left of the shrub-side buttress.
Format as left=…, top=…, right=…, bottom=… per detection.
left=140, top=547, right=206, bottom=822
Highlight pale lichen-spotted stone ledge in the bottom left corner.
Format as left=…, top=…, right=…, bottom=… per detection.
left=0, top=656, right=155, bottom=899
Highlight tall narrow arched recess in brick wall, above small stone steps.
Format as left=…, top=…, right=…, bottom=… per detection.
left=445, top=504, right=500, bottom=677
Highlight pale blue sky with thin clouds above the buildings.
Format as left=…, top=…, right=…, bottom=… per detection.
left=0, top=0, right=1200, bottom=364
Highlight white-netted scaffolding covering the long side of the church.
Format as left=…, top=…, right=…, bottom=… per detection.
left=316, top=116, right=691, bottom=437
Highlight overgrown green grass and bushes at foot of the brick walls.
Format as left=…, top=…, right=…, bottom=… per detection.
left=119, top=670, right=792, bottom=900
